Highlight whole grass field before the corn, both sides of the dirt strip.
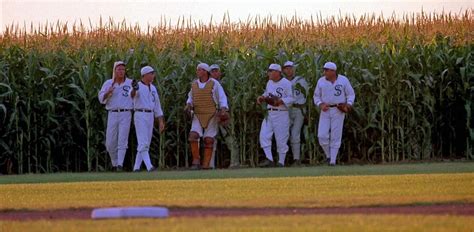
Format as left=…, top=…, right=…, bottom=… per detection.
left=0, top=162, right=474, bottom=231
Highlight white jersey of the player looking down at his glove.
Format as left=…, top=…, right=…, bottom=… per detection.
left=263, top=78, right=295, bottom=110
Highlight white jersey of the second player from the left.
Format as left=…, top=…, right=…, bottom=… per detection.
left=130, top=81, right=163, bottom=118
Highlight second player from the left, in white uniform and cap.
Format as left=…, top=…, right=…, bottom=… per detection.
left=130, top=66, right=165, bottom=172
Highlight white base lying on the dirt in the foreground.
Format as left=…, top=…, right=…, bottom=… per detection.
left=91, top=207, right=169, bottom=219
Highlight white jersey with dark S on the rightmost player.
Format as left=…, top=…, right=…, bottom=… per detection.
left=313, top=75, right=355, bottom=106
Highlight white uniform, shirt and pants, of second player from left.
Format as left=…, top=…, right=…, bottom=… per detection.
left=130, top=81, right=163, bottom=170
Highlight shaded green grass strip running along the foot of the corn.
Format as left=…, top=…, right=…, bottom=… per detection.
left=0, top=162, right=474, bottom=184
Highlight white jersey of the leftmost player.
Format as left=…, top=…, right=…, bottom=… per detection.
left=99, top=78, right=133, bottom=110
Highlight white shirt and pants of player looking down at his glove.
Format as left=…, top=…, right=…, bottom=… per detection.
left=260, top=78, right=294, bottom=165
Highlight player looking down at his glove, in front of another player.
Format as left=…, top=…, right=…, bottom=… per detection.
left=257, top=64, right=294, bottom=167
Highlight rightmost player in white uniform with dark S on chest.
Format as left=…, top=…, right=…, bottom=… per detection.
left=313, top=62, right=355, bottom=166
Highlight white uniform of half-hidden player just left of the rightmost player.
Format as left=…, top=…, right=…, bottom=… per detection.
left=290, top=76, right=309, bottom=160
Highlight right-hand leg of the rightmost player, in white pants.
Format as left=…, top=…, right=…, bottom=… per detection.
left=329, top=108, right=345, bottom=165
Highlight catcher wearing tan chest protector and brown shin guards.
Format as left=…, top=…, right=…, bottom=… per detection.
left=185, top=63, right=229, bottom=170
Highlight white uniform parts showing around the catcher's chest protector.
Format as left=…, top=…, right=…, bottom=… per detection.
left=186, top=77, right=229, bottom=138
